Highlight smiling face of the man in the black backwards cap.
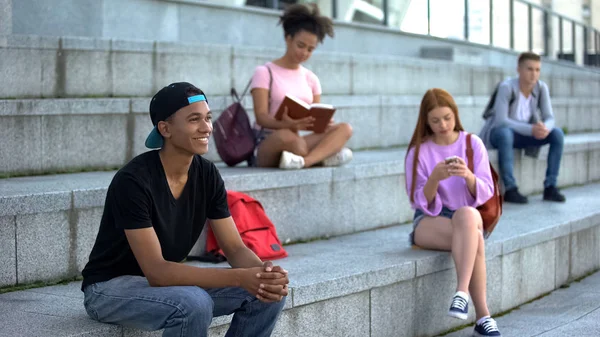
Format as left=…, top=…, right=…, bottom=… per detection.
left=158, top=101, right=213, bottom=155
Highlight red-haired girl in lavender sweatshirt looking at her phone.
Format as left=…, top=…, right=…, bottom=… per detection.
left=405, top=89, right=501, bottom=337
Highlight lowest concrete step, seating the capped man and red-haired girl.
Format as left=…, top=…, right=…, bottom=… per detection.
left=0, top=184, right=600, bottom=337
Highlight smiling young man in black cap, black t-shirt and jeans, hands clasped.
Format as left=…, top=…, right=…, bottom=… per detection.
left=82, top=83, right=288, bottom=337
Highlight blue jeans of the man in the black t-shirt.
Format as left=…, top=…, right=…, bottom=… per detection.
left=84, top=276, right=285, bottom=337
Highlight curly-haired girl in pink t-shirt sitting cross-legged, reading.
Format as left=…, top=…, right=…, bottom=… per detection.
left=251, top=4, right=352, bottom=169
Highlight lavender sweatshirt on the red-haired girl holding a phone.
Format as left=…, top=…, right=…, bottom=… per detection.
left=404, top=131, right=494, bottom=216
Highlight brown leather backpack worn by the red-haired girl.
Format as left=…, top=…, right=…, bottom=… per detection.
left=467, top=133, right=504, bottom=239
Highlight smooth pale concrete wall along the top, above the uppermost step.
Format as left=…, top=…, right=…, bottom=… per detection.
left=0, top=0, right=596, bottom=66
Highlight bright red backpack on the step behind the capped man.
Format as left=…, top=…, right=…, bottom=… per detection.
left=206, top=191, right=288, bottom=260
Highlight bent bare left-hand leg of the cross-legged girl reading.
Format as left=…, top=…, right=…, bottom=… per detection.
left=257, top=129, right=308, bottom=167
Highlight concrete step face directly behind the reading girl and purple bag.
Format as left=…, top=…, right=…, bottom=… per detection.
left=0, top=94, right=600, bottom=175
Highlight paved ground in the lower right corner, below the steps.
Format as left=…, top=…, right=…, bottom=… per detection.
left=446, top=272, right=600, bottom=337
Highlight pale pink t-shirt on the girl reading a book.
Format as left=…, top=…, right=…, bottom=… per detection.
left=250, top=62, right=321, bottom=116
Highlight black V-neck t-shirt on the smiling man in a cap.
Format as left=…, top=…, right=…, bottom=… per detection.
left=81, top=151, right=230, bottom=289
